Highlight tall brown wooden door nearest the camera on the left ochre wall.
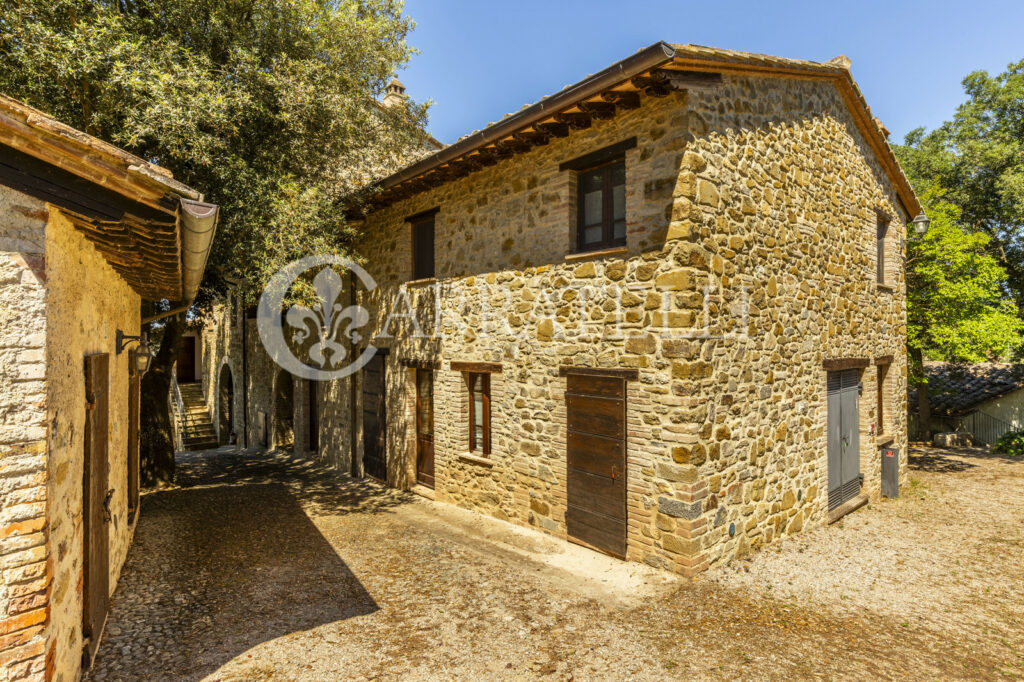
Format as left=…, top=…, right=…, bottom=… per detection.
left=82, top=353, right=113, bottom=665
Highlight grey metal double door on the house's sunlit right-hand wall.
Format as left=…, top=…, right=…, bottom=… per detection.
left=827, top=370, right=860, bottom=509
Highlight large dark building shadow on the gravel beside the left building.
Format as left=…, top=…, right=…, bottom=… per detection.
left=88, top=451, right=402, bottom=680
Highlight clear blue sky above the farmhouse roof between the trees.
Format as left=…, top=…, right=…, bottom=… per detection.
left=398, top=0, right=1024, bottom=143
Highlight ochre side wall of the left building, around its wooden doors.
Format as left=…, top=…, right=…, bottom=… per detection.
left=46, top=211, right=140, bottom=680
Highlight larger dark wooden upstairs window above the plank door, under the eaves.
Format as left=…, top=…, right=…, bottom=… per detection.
left=577, top=159, right=626, bottom=252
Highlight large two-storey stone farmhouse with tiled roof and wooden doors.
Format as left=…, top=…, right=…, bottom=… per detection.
left=200, top=43, right=922, bottom=576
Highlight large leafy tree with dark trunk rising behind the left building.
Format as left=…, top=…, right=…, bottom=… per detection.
left=0, top=0, right=426, bottom=483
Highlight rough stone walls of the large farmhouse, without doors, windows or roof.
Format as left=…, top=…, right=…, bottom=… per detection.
left=355, top=77, right=907, bottom=573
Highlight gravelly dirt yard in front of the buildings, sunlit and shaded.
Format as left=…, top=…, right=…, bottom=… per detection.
left=87, top=450, right=1024, bottom=681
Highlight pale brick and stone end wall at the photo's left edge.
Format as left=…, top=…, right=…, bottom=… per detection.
left=0, top=185, right=51, bottom=682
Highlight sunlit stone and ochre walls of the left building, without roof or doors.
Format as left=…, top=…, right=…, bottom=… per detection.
left=0, top=182, right=139, bottom=680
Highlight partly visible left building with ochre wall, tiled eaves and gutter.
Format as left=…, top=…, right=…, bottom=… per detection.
left=0, top=96, right=216, bottom=681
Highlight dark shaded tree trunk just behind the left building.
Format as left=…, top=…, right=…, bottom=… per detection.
left=139, top=312, right=185, bottom=487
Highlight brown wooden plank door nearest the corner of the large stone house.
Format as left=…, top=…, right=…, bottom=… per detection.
left=565, top=375, right=627, bottom=558
